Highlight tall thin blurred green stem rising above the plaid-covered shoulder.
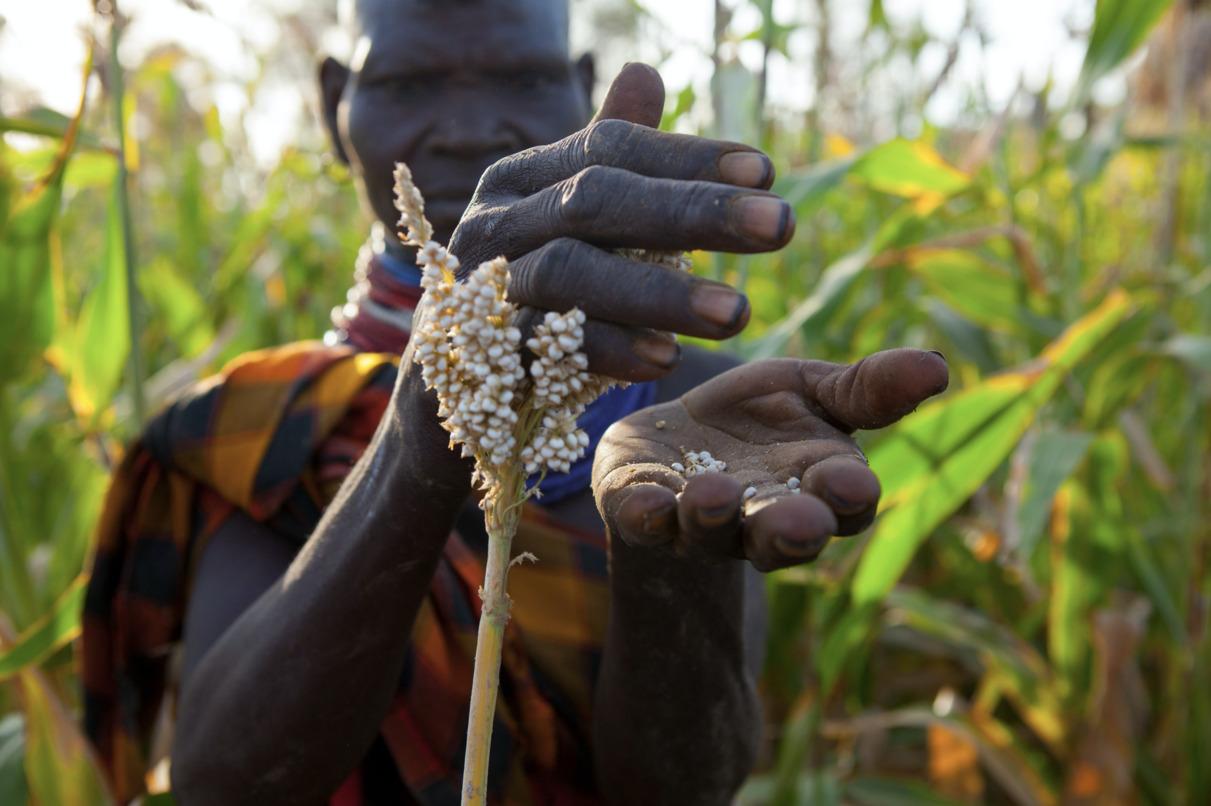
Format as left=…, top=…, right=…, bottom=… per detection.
left=108, top=0, right=147, bottom=427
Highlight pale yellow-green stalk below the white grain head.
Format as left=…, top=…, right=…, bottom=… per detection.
left=463, top=468, right=526, bottom=806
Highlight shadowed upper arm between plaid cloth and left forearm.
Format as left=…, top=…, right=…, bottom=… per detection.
left=180, top=511, right=298, bottom=687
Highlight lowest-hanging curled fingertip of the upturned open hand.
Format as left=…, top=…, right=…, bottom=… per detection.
left=744, top=494, right=837, bottom=571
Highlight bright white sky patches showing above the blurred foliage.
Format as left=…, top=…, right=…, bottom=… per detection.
left=0, top=0, right=1099, bottom=156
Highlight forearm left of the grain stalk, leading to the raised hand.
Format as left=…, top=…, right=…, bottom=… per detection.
left=173, top=377, right=469, bottom=804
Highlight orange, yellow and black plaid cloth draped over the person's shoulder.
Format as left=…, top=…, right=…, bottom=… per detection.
left=82, top=342, right=607, bottom=806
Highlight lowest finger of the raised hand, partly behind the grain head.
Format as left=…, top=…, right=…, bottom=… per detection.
left=516, top=307, right=681, bottom=384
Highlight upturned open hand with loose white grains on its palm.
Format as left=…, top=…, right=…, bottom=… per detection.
left=593, top=349, right=948, bottom=571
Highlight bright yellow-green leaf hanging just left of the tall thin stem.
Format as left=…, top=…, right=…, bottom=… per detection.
left=69, top=178, right=131, bottom=420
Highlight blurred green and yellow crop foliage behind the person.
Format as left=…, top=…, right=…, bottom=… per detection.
left=0, top=0, right=1211, bottom=805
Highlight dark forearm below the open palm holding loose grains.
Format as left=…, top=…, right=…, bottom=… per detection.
left=593, top=540, right=762, bottom=804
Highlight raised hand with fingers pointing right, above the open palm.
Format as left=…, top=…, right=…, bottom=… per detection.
left=450, top=64, right=794, bottom=380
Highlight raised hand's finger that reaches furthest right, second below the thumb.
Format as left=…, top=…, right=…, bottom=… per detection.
left=481, top=166, right=794, bottom=260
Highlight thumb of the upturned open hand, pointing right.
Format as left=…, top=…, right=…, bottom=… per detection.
left=800, top=349, right=949, bottom=431
